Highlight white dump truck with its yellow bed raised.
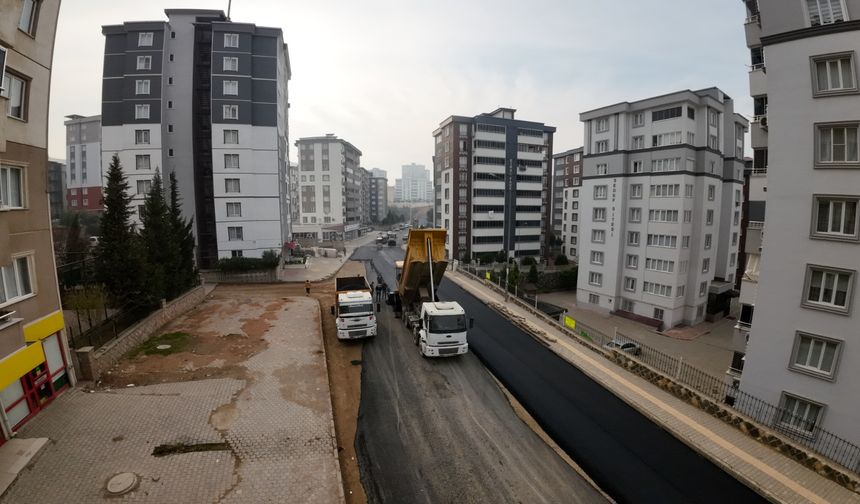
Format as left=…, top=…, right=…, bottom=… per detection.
left=391, top=229, right=466, bottom=357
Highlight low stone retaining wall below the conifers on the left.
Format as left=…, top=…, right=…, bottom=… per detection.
left=75, top=285, right=205, bottom=381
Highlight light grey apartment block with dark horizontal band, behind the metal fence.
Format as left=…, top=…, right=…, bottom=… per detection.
left=577, top=88, right=748, bottom=327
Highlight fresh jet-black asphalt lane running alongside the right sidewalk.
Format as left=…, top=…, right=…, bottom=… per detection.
left=362, top=245, right=765, bottom=503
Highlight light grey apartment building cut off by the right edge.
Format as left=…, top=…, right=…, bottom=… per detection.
left=740, top=0, right=860, bottom=445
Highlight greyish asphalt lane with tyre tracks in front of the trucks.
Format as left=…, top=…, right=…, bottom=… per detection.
left=353, top=247, right=606, bottom=504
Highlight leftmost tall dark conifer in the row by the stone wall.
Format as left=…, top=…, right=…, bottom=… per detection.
left=95, top=154, right=141, bottom=304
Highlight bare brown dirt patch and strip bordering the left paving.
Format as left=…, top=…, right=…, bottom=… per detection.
left=102, top=261, right=367, bottom=504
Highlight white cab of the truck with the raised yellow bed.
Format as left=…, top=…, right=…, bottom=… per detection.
left=415, top=301, right=469, bottom=357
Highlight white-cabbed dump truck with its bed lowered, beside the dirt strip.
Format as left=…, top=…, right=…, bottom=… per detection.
left=331, top=275, right=376, bottom=339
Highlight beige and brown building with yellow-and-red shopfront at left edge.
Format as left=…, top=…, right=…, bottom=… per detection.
left=0, top=0, right=75, bottom=438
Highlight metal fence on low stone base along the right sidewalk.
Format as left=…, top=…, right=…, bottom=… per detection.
left=458, top=265, right=860, bottom=473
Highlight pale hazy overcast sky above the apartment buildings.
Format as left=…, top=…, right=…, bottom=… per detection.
left=49, top=0, right=752, bottom=184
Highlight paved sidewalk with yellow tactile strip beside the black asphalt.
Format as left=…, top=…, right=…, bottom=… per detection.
left=446, top=272, right=860, bottom=504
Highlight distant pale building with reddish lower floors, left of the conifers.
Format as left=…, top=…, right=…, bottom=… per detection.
left=64, top=115, right=105, bottom=211
